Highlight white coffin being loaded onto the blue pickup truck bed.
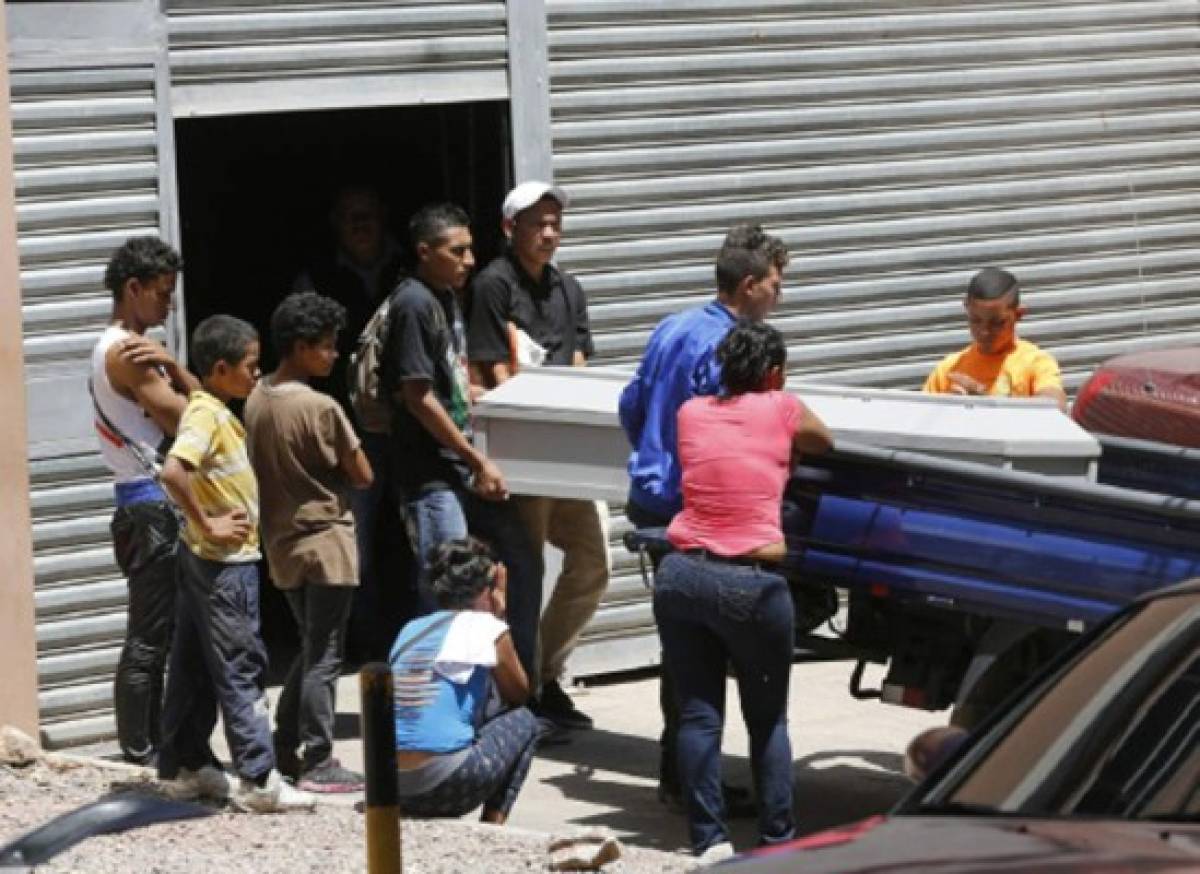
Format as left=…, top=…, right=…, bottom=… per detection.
left=474, top=367, right=1100, bottom=502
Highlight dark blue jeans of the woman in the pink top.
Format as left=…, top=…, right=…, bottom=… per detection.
left=654, top=553, right=796, bottom=855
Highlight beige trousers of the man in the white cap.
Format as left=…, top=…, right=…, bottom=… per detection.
left=515, top=495, right=612, bottom=689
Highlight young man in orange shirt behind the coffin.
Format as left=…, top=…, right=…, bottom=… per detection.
left=924, top=267, right=1067, bottom=411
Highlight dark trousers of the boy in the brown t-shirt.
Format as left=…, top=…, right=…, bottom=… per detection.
left=275, top=582, right=355, bottom=768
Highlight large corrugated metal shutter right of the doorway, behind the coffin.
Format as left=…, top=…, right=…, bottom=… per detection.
left=547, top=0, right=1200, bottom=672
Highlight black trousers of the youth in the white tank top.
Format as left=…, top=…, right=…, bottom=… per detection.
left=109, top=501, right=179, bottom=765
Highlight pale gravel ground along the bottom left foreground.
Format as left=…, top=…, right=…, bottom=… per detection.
left=0, top=762, right=694, bottom=874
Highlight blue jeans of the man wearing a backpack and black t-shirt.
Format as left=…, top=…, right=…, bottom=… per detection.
left=407, top=489, right=544, bottom=681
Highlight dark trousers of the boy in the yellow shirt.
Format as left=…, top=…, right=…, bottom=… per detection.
left=158, top=546, right=275, bottom=779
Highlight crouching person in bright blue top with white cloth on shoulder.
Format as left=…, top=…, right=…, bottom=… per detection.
left=390, top=537, right=539, bottom=825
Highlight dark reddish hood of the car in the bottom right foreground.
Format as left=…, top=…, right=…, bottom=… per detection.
left=716, top=816, right=1200, bottom=874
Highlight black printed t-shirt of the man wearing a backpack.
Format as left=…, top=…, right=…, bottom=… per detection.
left=380, top=277, right=470, bottom=497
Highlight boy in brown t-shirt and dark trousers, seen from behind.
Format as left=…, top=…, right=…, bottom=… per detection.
left=246, top=292, right=372, bottom=792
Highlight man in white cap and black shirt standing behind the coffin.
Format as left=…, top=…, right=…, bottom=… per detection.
left=467, top=181, right=610, bottom=729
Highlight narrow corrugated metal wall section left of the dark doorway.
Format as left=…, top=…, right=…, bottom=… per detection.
left=12, top=65, right=171, bottom=747
